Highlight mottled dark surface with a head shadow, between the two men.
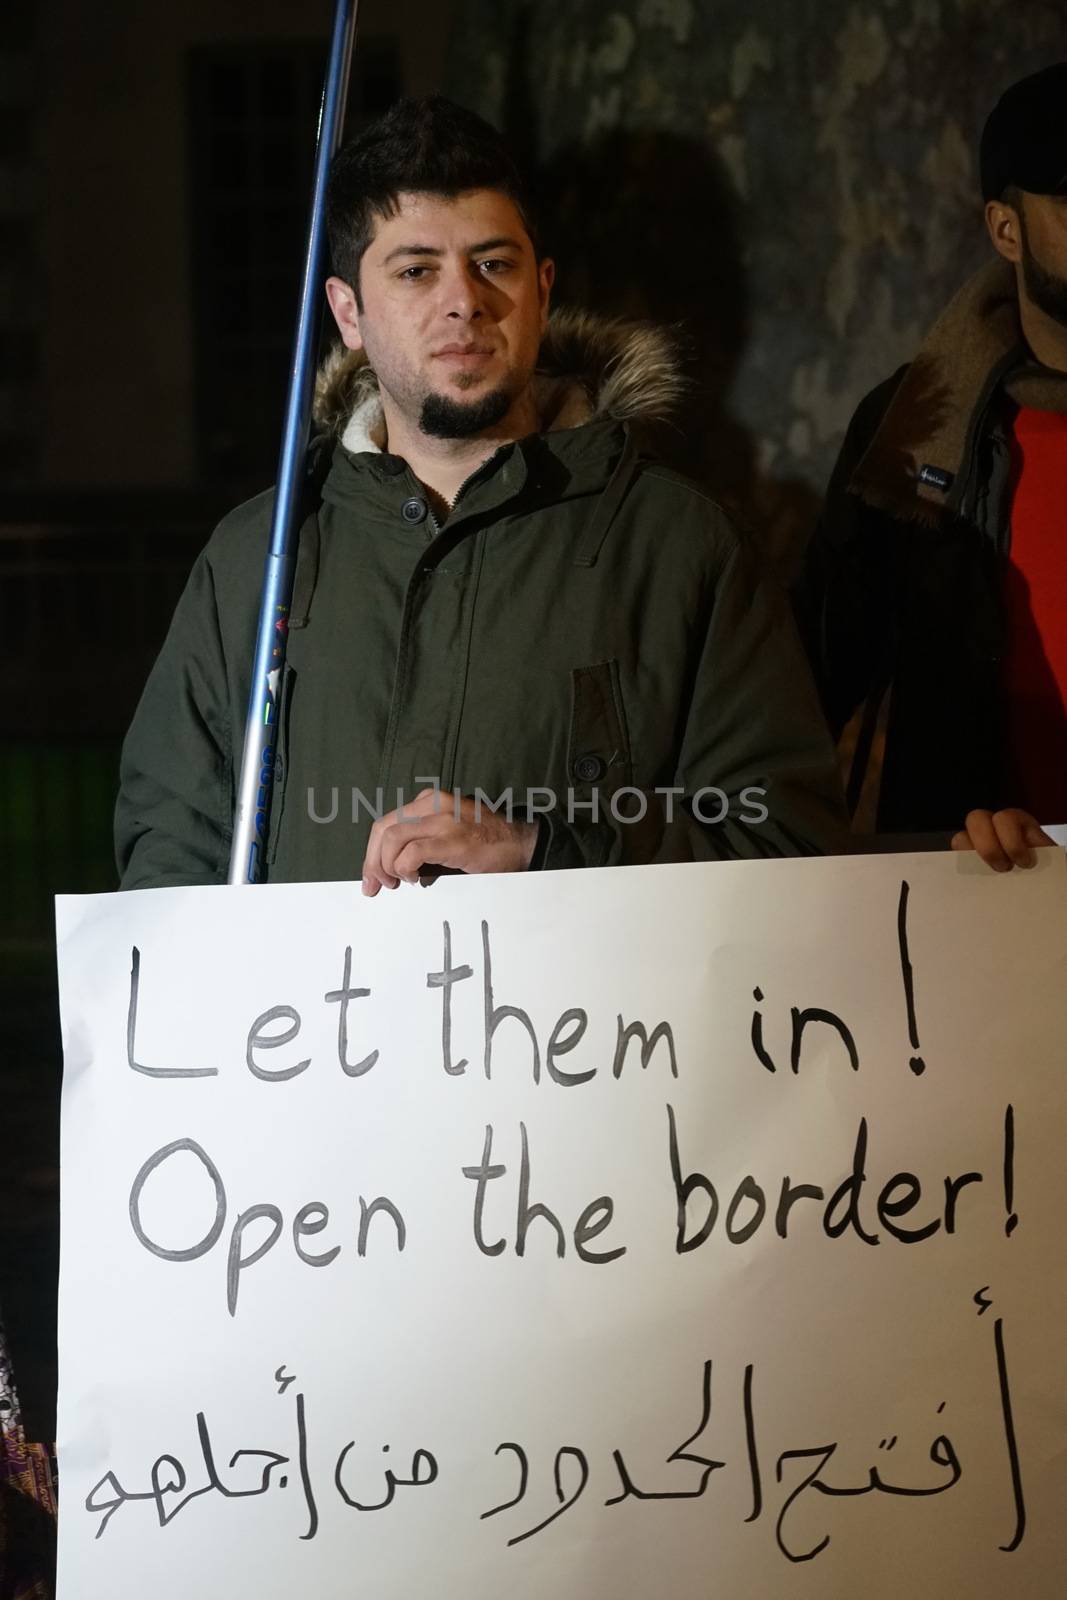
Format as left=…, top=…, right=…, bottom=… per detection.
left=446, top=0, right=1067, bottom=555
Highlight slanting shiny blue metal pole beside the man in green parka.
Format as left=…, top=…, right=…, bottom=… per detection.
left=229, top=0, right=358, bottom=883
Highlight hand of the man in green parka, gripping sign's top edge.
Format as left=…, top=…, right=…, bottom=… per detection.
left=363, top=789, right=537, bottom=894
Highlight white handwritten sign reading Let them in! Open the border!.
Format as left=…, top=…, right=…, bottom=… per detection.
left=58, top=851, right=1067, bottom=1600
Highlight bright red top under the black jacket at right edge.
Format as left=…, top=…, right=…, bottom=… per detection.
left=1005, top=406, right=1067, bottom=822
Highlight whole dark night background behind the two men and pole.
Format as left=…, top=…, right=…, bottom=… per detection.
left=0, top=0, right=1067, bottom=1472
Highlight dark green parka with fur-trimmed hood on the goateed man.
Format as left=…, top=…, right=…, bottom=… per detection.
left=115, top=314, right=841, bottom=888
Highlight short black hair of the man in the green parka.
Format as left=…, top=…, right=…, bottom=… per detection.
left=326, top=94, right=539, bottom=301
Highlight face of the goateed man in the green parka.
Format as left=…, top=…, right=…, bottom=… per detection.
left=326, top=189, right=552, bottom=438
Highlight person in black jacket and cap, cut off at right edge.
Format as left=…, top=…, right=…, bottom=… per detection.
left=798, top=62, right=1067, bottom=870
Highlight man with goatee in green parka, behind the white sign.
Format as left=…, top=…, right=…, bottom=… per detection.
left=117, top=98, right=837, bottom=894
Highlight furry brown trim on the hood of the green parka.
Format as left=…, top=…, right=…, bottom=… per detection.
left=314, top=309, right=686, bottom=453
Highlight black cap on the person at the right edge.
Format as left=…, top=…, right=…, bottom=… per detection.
left=979, top=61, right=1067, bottom=200
